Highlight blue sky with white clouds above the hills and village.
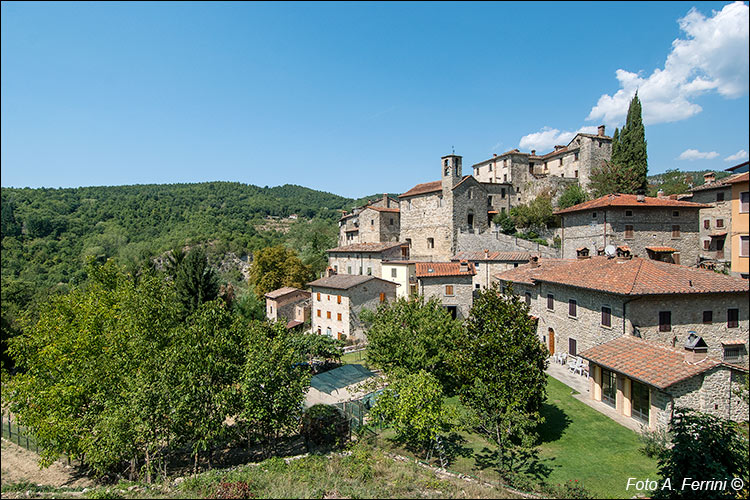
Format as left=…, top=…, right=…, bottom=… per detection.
left=0, top=2, right=750, bottom=197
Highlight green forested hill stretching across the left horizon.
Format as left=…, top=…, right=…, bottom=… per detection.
left=1, top=182, right=354, bottom=289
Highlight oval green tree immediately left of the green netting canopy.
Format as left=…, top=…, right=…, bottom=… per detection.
left=239, top=321, right=310, bottom=453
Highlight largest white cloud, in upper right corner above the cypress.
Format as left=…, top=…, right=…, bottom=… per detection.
left=586, top=2, right=750, bottom=126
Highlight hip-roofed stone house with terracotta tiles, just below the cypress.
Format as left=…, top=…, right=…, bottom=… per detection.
left=555, top=194, right=709, bottom=266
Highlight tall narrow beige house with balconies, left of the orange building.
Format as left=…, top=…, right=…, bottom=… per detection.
left=683, top=172, right=741, bottom=269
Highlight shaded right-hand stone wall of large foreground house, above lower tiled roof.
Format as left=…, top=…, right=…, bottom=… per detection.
left=627, top=292, right=750, bottom=366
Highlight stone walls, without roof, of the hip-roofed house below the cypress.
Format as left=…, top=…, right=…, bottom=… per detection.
left=561, top=207, right=700, bottom=266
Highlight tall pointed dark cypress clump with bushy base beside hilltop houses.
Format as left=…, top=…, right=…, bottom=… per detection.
left=589, top=92, right=648, bottom=197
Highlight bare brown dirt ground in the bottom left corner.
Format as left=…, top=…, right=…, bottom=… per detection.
left=0, top=438, right=94, bottom=488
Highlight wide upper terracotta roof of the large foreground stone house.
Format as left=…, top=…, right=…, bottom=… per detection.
left=496, top=256, right=750, bottom=295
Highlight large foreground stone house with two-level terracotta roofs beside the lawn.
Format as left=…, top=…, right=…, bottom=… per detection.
left=496, top=257, right=748, bottom=427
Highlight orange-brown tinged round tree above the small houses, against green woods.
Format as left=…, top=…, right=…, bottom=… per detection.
left=250, top=245, right=313, bottom=297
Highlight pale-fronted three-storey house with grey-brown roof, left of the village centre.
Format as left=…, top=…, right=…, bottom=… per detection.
left=307, top=271, right=398, bottom=343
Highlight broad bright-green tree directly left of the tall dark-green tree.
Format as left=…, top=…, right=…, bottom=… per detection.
left=362, top=297, right=461, bottom=393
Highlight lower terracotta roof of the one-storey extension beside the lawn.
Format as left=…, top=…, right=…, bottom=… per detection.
left=580, top=336, right=721, bottom=389
